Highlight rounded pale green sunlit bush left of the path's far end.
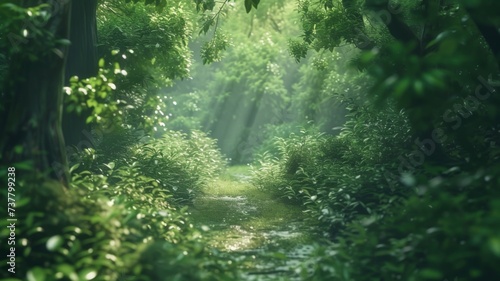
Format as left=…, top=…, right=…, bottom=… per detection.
left=131, top=130, right=226, bottom=202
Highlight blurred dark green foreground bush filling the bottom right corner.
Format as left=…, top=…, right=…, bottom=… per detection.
left=294, top=165, right=500, bottom=281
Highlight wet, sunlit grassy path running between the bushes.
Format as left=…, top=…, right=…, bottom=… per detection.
left=191, top=166, right=314, bottom=280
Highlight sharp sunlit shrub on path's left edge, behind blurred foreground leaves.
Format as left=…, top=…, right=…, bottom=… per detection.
left=74, top=159, right=237, bottom=280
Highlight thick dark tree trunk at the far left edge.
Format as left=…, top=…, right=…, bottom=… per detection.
left=0, top=0, right=71, bottom=186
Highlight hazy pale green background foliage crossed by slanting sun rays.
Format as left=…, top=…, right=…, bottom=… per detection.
left=166, top=1, right=348, bottom=164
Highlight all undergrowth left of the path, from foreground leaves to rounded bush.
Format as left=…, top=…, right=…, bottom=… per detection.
left=0, top=131, right=234, bottom=281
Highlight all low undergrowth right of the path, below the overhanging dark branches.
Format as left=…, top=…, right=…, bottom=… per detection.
left=253, top=98, right=500, bottom=281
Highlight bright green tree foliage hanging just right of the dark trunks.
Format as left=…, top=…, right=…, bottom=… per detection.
left=97, top=0, right=193, bottom=131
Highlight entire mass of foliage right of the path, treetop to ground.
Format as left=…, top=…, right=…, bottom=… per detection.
left=255, top=1, right=499, bottom=280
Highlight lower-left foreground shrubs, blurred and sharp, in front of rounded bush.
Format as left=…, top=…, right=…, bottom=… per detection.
left=0, top=159, right=238, bottom=280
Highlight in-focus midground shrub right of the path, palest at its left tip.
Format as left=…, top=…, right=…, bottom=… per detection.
left=253, top=101, right=410, bottom=235
